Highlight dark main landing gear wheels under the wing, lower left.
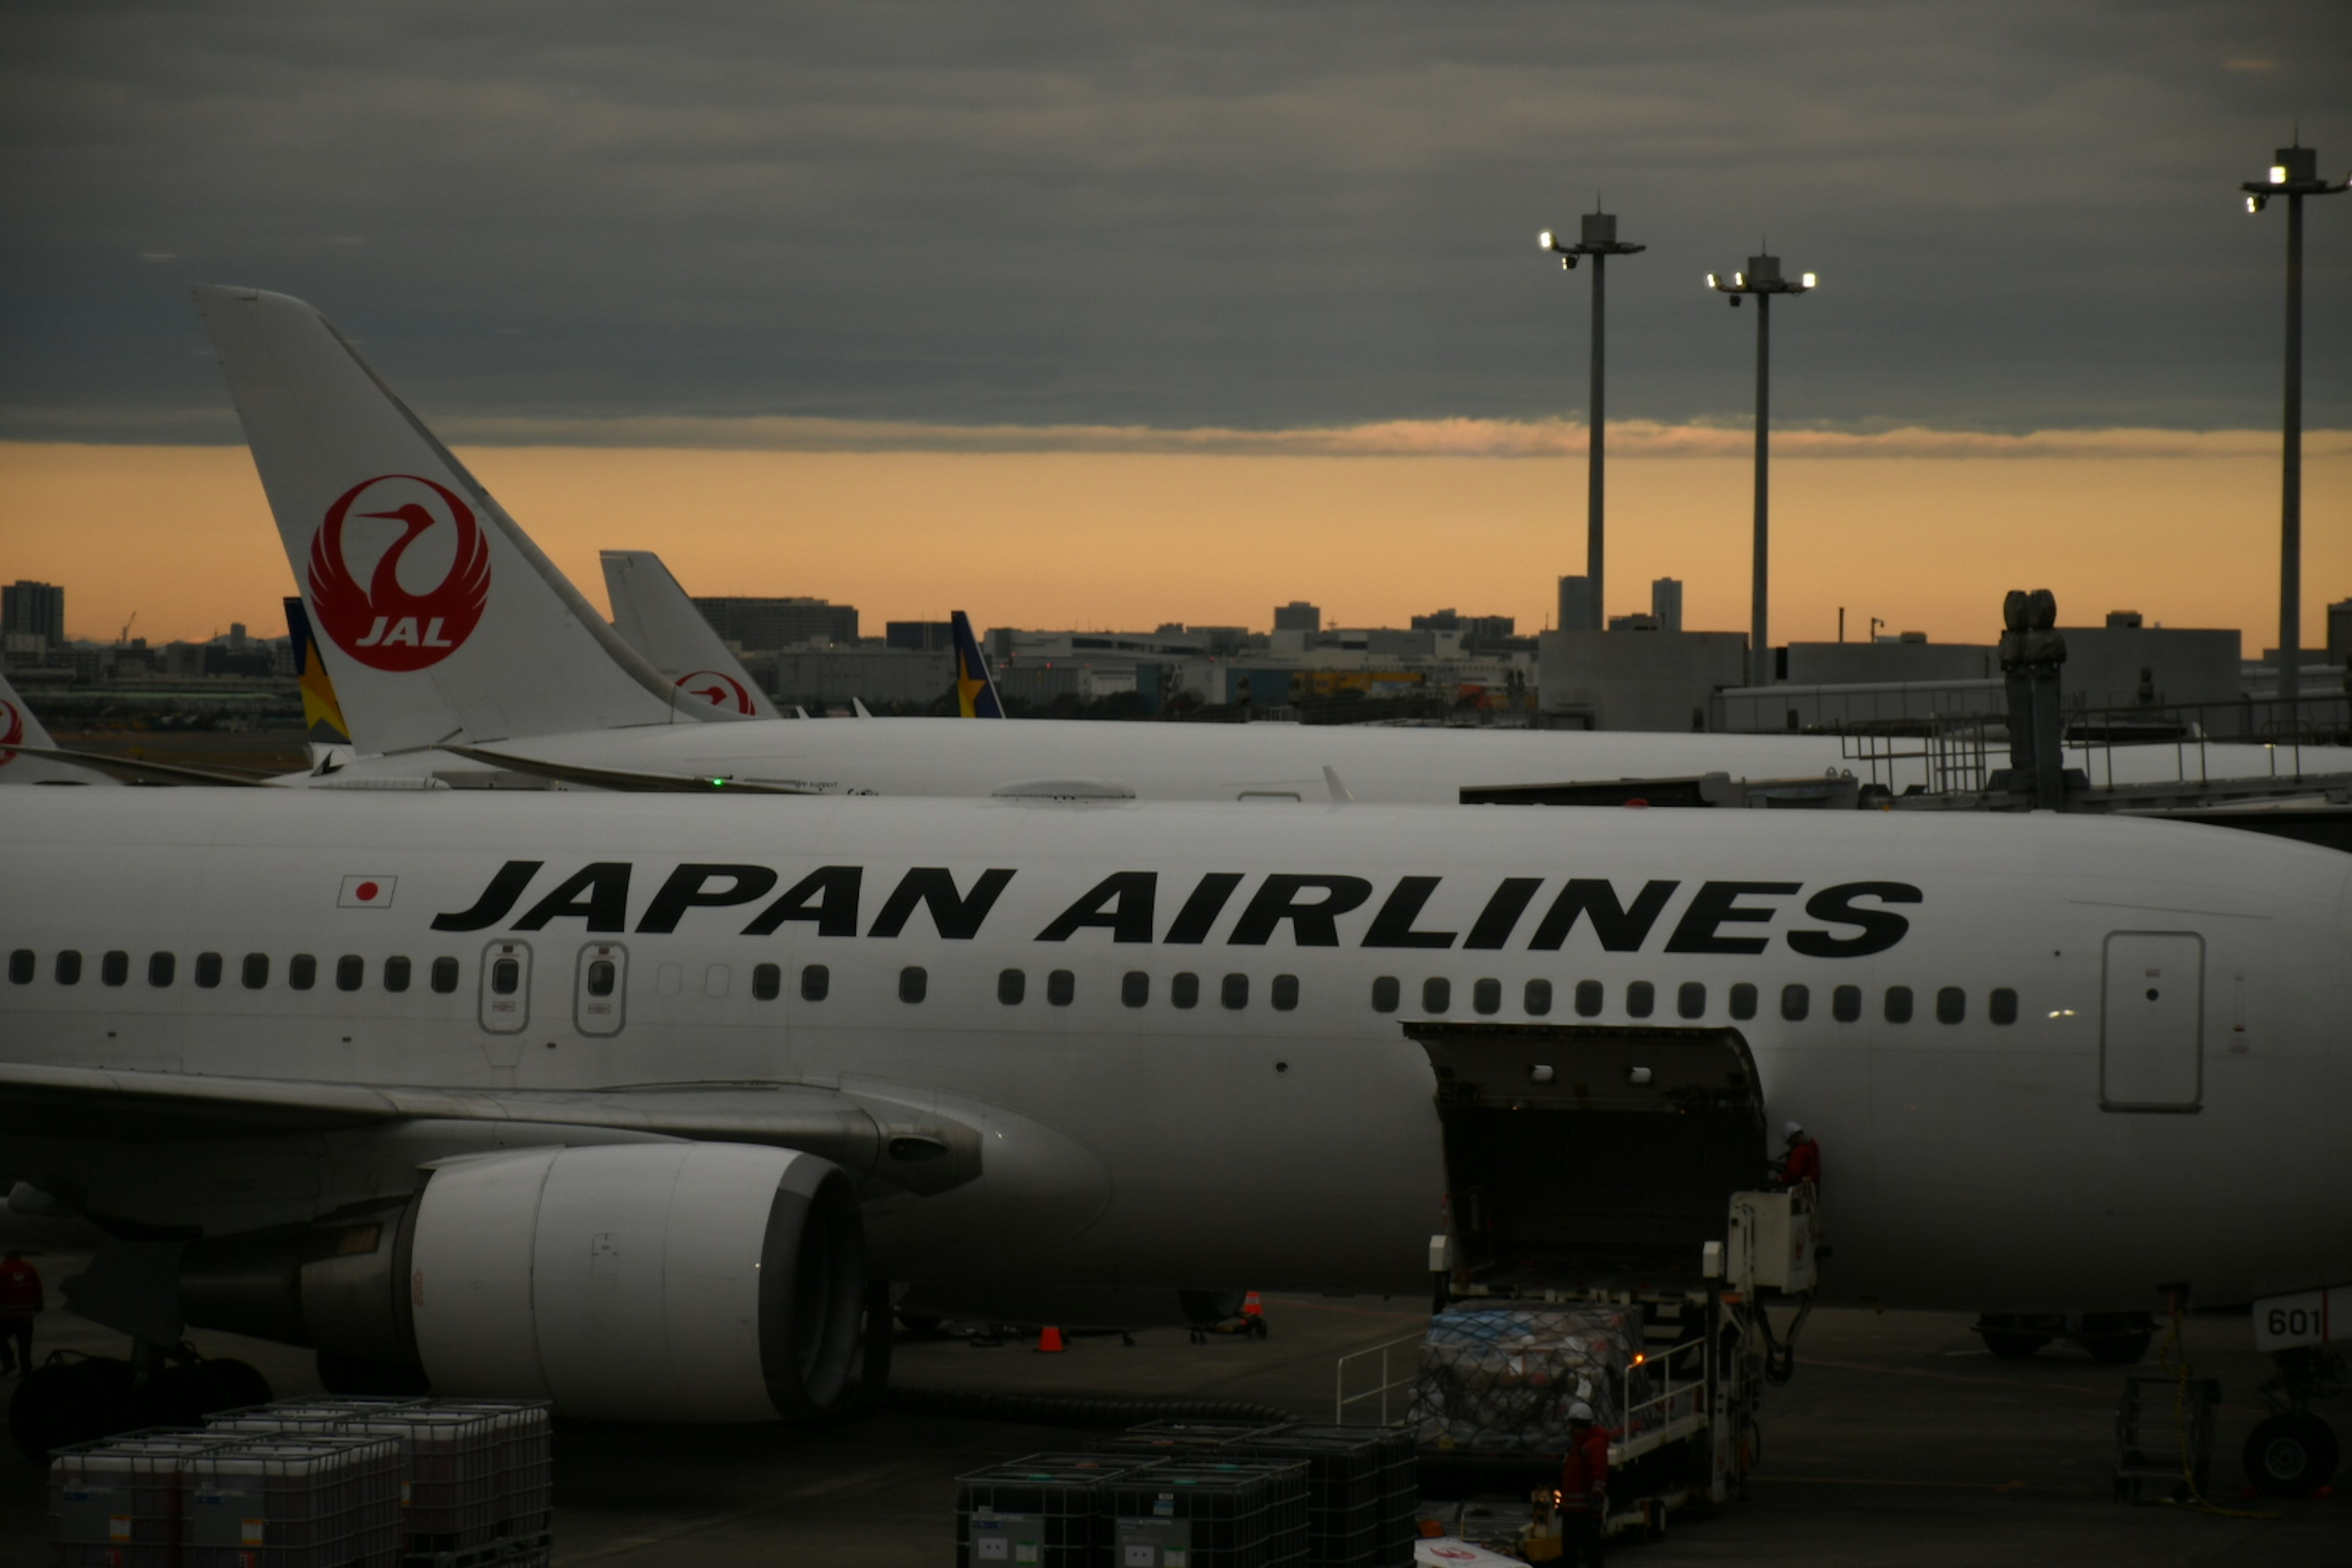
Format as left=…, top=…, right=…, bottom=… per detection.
left=7, top=1344, right=271, bottom=1464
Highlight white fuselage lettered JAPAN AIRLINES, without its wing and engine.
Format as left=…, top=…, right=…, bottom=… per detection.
left=0, top=785, right=2352, bottom=1307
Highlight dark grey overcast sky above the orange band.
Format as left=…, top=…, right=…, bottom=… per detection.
left=0, top=0, right=2352, bottom=442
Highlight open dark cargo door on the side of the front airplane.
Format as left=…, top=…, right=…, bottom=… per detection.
left=1404, top=1020, right=1764, bottom=1291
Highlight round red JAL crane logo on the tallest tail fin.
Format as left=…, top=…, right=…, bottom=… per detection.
left=311, top=472, right=489, bottom=670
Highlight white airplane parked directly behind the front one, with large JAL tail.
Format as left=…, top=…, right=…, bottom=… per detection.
left=195, top=287, right=2352, bottom=804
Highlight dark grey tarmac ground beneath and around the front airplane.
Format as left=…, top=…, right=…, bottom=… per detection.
left=0, top=1257, right=2352, bottom=1568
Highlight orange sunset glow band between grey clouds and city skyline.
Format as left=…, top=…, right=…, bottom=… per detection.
left=0, top=432, right=2352, bottom=656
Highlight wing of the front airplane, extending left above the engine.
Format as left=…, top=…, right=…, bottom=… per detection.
left=0, top=1063, right=981, bottom=1192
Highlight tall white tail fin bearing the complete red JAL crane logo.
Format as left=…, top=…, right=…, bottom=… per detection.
left=195, top=287, right=706, bottom=752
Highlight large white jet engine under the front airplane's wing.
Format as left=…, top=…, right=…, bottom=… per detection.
left=179, top=1142, right=865, bottom=1422
